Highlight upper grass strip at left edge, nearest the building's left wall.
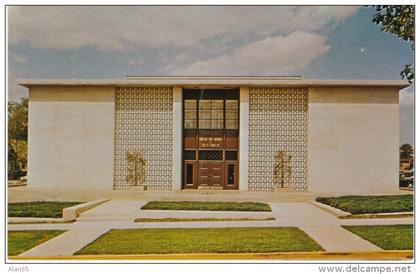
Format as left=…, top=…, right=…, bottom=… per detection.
left=7, top=202, right=80, bottom=218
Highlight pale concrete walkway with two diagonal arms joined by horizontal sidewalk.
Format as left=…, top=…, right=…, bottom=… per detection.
left=8, top=200, right=413, bottom=257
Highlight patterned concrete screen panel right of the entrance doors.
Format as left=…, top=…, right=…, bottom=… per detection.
left=248, top=88, right=308, bottom=191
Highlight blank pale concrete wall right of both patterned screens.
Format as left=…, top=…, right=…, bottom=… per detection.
left=308, top=88, right=399, bottom=194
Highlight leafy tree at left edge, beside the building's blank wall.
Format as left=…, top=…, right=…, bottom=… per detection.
left=7, top=98, right=28, bottom=179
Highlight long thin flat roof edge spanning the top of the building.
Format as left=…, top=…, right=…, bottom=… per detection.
left=18, top=76, right=410, bottom=89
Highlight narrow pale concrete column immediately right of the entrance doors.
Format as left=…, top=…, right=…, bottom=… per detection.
left=239, top=87, right=249, bottom=191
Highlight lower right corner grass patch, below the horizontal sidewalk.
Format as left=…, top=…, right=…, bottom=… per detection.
left=344, top=225, right=413, bottom=250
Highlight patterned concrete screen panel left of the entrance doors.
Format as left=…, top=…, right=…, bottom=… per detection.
left=114, top=87, right=173, bottom=190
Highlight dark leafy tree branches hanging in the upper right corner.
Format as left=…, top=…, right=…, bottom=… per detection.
left=372, top=5, right=415, bottom=83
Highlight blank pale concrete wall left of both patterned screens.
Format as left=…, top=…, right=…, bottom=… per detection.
left=28, top=86, right=114, bottom=190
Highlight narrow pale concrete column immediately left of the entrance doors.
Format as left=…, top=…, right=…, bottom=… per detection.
left=172, top=87, right=182, bottom=190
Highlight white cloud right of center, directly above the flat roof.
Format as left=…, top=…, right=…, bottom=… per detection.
left=166, top=31, right=329, bottom=75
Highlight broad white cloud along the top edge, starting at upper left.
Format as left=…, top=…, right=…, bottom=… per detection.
left=8, top=6, right=358, bottom=50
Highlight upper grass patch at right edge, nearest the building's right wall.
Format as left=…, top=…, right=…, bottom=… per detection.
left=316, top=195, right=413, bottom=214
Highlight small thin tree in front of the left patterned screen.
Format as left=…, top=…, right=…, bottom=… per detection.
left=126, top=152, right=146, bottom=186
